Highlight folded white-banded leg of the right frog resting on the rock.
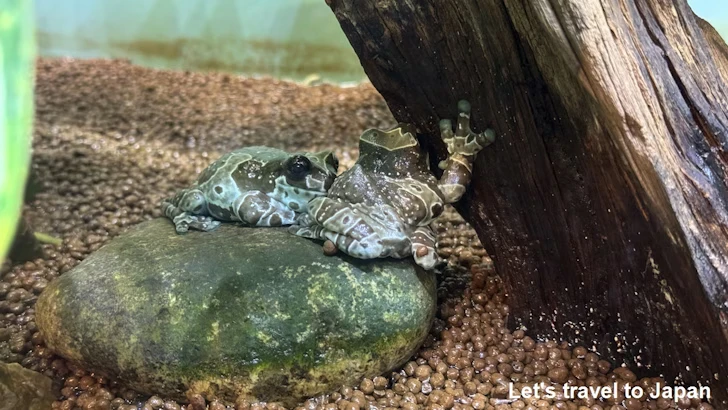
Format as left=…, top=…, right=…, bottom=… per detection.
left=289, top=197, right=411, bottom=259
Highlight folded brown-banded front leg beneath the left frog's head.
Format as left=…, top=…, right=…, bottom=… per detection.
left=234, top=191, right=296, bottom=226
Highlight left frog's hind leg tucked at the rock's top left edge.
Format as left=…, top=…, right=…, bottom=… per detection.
left=162, top=189, right=220, bottom=233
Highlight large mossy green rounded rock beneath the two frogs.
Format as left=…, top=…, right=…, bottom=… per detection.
left=36, top=219, right=436, bottom=404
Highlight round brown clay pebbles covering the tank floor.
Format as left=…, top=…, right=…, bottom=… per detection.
left=0, top=59, right=713, bottom=410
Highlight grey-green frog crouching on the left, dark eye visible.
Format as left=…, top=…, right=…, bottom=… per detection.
left=162, top=146, right=339, bottom=234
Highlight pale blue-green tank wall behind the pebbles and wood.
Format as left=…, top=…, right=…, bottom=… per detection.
left=36, top=0, right=728, bottom=82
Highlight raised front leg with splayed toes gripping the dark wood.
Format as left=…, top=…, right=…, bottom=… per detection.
left=439, top=100, right=495, bottom=203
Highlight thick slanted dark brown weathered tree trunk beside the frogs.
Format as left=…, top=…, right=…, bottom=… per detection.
left=327, top=0, right=728, bottom=407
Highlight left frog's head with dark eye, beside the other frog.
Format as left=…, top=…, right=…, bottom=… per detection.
left=275, top=151, right=339, bottom=212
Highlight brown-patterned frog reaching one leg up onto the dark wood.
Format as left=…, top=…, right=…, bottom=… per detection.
left=288, top=100, right=495, bottom=270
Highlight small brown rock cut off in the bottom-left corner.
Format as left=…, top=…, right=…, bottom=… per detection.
left=0, top=363, right=56, bottom=410
